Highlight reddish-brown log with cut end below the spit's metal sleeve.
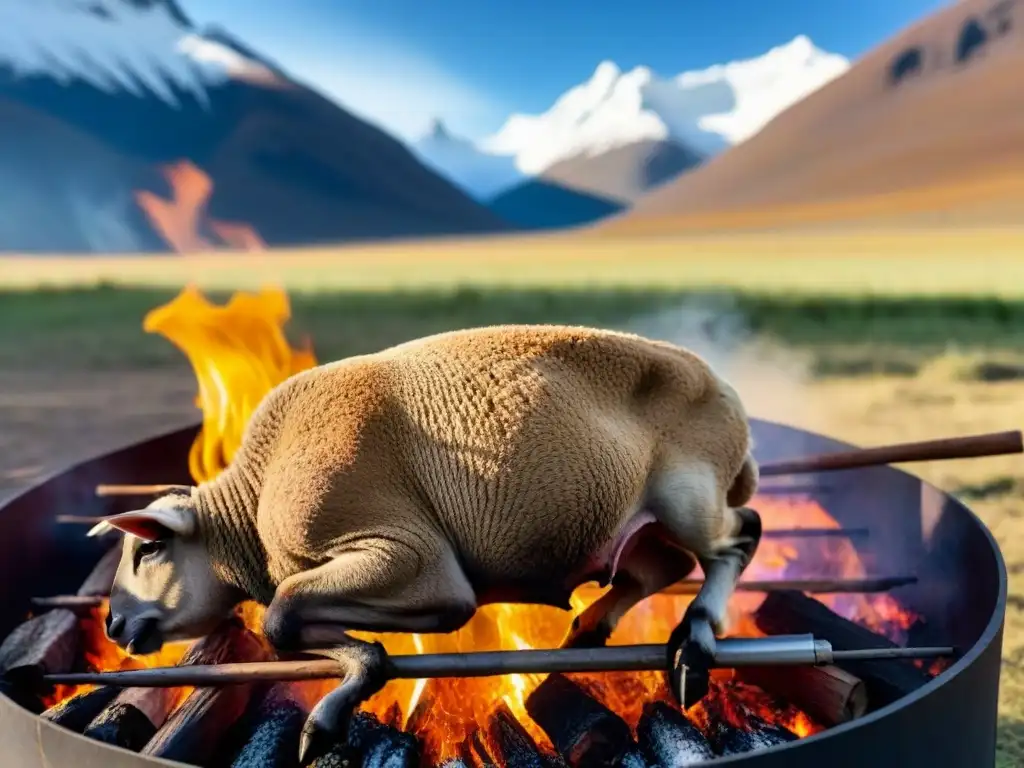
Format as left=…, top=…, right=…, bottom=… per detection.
left=736, top=665, right=867, bottom=727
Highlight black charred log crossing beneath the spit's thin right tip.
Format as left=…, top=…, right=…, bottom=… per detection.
left=754, top=592, right=930, bottom=710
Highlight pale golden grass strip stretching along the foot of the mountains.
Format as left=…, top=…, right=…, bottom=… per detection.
left=6, top=227, right=1024, bottom=298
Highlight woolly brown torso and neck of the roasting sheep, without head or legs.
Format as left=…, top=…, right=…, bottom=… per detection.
left=190, top=326, right=756, bottom=607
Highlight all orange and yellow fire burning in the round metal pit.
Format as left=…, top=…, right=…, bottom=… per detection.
left=29, top=288, right=937, bottom=765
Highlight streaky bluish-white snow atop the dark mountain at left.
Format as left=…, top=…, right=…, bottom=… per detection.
left=0, top=0, right=279, bottom=106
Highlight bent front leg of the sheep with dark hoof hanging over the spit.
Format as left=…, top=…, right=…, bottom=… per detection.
left=264, top=539, right=476, bottom=764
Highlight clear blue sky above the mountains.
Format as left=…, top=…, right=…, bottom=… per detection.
left=179, top=0, right=947, bottom=138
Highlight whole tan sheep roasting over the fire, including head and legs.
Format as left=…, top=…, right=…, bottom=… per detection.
left=100, top=326, right=760, bottom=757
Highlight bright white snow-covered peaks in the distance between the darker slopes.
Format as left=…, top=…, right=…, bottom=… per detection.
left=414, top=35, right=850, bottom=199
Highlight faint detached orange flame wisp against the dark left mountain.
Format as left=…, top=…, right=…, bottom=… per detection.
left=135, top=160, right=264, bottom=253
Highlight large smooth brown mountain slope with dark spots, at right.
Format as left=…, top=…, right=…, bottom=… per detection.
left=598, top=0, right=1024, bottom=232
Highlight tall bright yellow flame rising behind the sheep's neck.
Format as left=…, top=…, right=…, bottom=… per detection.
left=142, top=286, right=316, bottom=482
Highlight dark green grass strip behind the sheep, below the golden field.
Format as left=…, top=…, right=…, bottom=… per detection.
left=0, top=286, right=1024, bottom=378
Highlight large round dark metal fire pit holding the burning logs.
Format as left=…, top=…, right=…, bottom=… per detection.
left=0, top=421, right=1007, bottom=768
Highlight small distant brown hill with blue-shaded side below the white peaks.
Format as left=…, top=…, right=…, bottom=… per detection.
left=541, top=139, right=703, bottom=203
